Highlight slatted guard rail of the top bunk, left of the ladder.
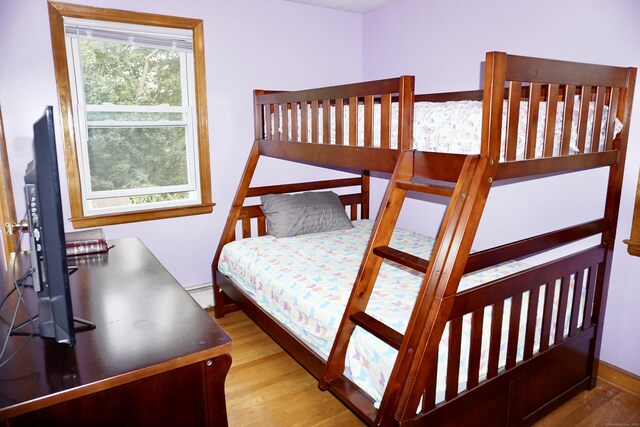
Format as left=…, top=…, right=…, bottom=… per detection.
left=254, top=76, right=414, bottom=151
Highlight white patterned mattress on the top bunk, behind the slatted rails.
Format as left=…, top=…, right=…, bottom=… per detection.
left=271, top=97, right=622, bottom=160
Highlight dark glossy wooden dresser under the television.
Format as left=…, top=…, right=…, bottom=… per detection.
left=0, top=238, right=231, bottom=426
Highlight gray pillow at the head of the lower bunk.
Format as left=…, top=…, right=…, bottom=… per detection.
left=260, top=191, right=353, bottom=237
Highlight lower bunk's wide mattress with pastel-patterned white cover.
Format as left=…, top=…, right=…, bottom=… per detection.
left=218, top=220, right=584, bottom=401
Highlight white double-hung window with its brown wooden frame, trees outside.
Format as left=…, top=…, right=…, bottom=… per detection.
left=49, top=2, right=213, bottom=228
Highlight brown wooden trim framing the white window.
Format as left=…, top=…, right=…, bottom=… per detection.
left=48, top=1, right=214, bottom=228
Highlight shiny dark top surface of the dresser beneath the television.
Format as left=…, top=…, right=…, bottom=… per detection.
left=0, top=238, right=231, bottom=419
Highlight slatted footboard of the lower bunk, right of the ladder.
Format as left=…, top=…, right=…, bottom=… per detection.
left=420, top=245, right=605, bottom=413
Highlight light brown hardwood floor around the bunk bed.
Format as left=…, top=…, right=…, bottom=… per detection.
left=210, top=311, right=640, bottom=427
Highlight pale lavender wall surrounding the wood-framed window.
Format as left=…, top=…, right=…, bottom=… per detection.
left=0, top=0, right=362, bottom=287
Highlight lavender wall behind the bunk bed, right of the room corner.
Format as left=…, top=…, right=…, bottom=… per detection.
left=363, top=0, right=640, bottom=375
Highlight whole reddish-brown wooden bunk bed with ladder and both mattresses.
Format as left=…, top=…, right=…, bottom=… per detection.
left=212, top=52, right=636, bottom=425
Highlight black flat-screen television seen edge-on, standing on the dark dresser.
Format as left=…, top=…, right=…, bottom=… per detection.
left=24, top=106, right=76, bottom=345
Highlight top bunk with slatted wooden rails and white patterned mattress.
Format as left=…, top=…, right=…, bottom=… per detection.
left=254, top=52, right=635, bottom=181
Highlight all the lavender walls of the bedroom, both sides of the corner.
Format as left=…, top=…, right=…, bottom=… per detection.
left=0, top=0, right=640, bottom=374
